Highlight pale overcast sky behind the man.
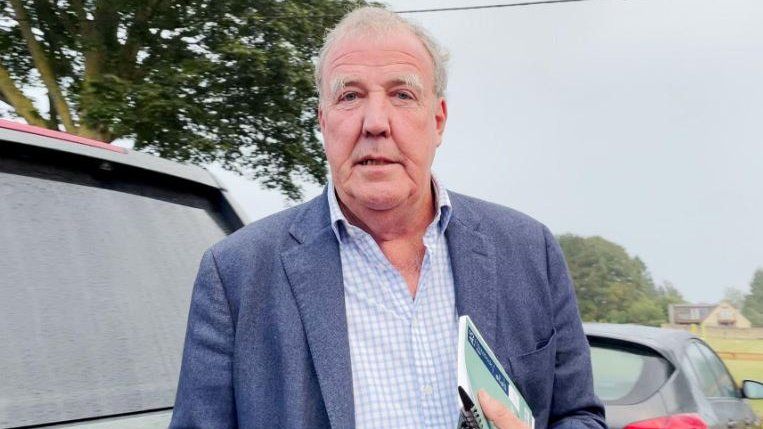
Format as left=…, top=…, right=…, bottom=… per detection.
left=215, top=0, right=763, bottom=302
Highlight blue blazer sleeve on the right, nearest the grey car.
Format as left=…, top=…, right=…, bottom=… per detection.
left=543, top=227, right=607, bottom=429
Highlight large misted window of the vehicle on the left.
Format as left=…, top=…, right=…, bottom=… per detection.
left=0, top=145, right=239, bottom=427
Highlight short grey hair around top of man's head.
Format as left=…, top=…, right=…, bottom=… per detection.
left=315, top=6, right=448, bottom=100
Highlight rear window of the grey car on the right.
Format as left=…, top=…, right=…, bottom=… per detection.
left=589, top=338, right=674, bottom=405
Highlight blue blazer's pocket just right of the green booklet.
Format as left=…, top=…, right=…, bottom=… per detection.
left=509, top=330, right=556, bottom=417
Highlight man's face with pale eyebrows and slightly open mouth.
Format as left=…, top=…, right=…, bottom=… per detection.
left=318, top=31, right=447, bottom=211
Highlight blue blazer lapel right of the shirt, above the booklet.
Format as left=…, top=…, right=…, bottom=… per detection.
left=445, top=192, right=498, bottom=347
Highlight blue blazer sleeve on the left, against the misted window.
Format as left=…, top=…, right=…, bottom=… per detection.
left=170, top=249, right=237, bottom=429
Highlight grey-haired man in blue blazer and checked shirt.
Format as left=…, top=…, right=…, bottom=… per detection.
left=171, top=8, right=604, bottom=429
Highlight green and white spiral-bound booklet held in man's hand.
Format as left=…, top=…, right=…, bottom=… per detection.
left=458, top=316, right=535, bottom=429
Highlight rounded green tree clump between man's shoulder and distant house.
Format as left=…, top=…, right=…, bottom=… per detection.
left=558, top=234, right=683, bottom=325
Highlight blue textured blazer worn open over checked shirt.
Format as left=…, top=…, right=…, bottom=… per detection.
left=170, top=192, right=606, bottom=429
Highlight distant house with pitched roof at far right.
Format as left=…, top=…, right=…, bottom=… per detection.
left=668, top=301, right=752, bottom=328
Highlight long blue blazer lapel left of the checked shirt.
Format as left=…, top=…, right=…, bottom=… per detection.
left=281, top=192, right=355, bottom=428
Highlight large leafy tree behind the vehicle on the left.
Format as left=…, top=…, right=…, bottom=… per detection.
left=0, top=0, right=362, bottom=199
